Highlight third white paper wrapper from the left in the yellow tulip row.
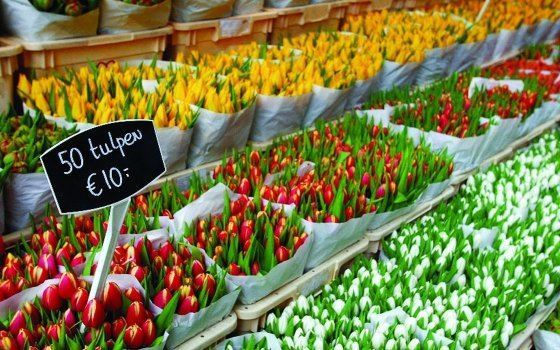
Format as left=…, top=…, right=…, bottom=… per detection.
left=249, top=93, right=312, bottom=142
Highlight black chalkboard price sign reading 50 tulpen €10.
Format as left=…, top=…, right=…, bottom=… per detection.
left=41, top=120, right=165, bottom=214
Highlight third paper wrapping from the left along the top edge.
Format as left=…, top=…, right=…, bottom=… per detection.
left=171, top=0, right=235, bottom=23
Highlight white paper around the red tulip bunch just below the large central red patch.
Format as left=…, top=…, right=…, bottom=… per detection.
left=174, top=184, right=313, bottom=304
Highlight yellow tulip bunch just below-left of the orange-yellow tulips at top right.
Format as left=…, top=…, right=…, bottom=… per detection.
left=343, top=10, right=486, bottom=63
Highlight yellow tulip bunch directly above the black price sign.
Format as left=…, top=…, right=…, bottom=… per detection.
left=18, top=64, right=196, bottom=130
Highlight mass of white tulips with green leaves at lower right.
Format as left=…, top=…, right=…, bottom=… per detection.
left=260, top=131, right=560, bottom=349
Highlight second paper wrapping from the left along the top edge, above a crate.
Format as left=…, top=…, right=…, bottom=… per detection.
left=99, top=0, right=171, bottom=34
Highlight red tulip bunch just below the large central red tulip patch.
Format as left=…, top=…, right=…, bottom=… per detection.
left=183, top=194, right=308, bottom=276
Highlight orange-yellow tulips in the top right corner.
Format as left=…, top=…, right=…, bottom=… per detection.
left=434, top=0, right=560, bottom=33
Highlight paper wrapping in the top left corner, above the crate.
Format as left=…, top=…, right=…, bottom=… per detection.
left=0, top=0, right=99, bottom=42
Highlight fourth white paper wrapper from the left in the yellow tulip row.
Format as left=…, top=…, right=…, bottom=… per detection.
left=302, top=85, right=352, bottom=127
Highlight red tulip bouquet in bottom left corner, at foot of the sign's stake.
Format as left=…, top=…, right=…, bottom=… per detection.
left=0, top=272, right=177, bottom=349
